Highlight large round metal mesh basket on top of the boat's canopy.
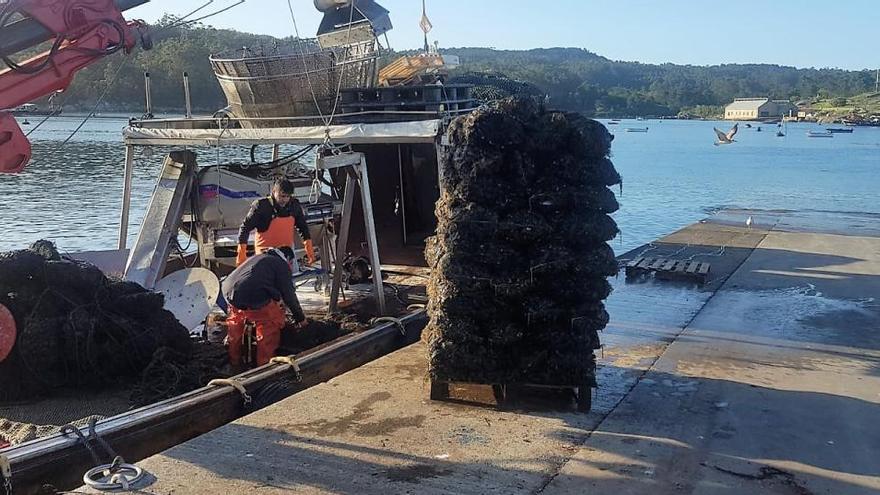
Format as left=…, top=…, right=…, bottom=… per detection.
left=211, top=40, right=378, bottom=127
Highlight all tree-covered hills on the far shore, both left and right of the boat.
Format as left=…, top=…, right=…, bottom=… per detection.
left=37, top=21, right=874, bottom=116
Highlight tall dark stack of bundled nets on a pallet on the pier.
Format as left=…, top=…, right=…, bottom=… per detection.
left=425, top=99, right=620, bottom=387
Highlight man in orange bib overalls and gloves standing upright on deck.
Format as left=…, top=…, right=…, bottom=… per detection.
left=235, top=177, right=315, bottom=265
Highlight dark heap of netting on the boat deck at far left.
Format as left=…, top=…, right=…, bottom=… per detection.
left=0, top=241, right=192, bottom=402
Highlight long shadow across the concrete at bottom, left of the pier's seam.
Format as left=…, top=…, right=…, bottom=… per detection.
left=164, top=424, right=540, bottom=494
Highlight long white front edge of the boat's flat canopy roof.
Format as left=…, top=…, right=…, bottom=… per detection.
left=122, top=120, right=440, bottom=146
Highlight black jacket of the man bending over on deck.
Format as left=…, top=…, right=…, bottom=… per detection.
left=223, top=253, right=306, bottom=322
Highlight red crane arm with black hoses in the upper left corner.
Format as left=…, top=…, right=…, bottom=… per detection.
left=0, top=0, right=151, bottom=173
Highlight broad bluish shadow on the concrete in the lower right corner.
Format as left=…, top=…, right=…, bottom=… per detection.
left=544, top=371, right=880, bottom=494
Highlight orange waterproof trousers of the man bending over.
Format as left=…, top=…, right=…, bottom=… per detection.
left=226, top=301, right=285, bottom=366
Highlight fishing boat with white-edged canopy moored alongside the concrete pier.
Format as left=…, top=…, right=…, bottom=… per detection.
left=0, top=0, right=484, bottom=493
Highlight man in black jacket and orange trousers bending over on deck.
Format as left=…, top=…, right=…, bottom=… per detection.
left=223, top=246, right=308, bottom=367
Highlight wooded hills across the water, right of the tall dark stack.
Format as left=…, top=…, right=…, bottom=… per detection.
left=446, top=48, right=874, bottom=116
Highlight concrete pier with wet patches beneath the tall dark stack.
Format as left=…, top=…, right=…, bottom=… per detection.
left=91, top=210, right=880, bottom=495
